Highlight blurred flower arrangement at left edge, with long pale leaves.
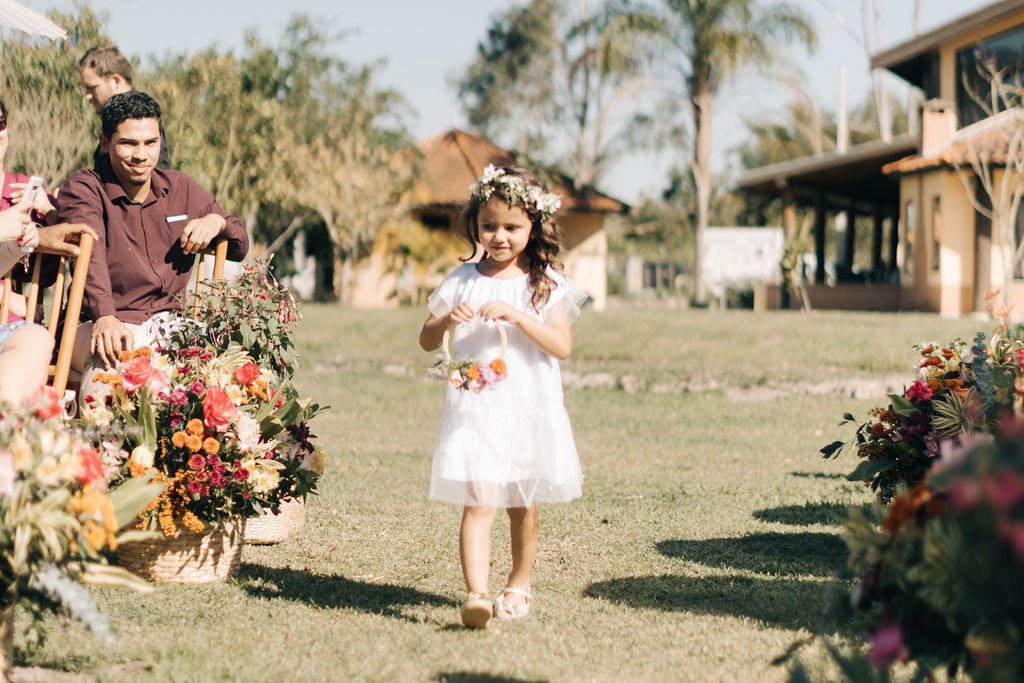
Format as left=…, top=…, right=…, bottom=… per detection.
left=0, top=395, right=161, bottom=655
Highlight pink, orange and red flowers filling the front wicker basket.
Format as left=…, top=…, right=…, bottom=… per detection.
left=82, top=344, right=326, bottom=537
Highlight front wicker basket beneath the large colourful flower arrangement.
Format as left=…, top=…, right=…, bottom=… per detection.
left=118, top=517, right=246, bottom=584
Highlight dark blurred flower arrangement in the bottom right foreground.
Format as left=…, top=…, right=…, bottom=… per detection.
left=819, top=430, right=1024, bottom=681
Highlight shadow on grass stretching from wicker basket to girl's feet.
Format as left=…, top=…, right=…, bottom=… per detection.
left=238, top=564, right=459, bottom=621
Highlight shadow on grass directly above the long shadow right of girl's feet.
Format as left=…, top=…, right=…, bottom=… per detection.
left=655, top=532, right=847, bottom=577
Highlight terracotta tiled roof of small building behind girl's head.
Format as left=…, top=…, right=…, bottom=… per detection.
left=417, top=129, right=629, bottom=213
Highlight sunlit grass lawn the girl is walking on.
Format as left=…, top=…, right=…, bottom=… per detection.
left=16, top=305, right=990, bottom=682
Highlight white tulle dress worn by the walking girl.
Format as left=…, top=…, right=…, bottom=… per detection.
left=427, top=263, right=587, bottom=508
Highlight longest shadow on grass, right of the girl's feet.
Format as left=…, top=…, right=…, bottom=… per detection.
left=583, top=574, right=831, bottom=630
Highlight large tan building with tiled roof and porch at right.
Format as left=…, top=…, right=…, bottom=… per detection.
left=739, top=0, right=1024, bottom=314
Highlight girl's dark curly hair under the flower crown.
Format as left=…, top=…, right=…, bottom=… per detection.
left=456, top=166, right=562, bottom=311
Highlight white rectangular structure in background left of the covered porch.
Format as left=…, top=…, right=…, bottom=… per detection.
left=703, top=227, right=785, bottom=298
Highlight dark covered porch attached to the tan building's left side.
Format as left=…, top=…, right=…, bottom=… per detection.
left=737, top=135, right=921, bottom=310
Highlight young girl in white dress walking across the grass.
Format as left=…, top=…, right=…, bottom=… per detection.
left=420, top=166, right=587, bottom=628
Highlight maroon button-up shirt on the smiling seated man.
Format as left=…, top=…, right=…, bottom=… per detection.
left=57, top=160, right=249, bottom=325
